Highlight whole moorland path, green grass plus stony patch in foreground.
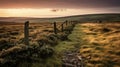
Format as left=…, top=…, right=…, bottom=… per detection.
left=55, top=24, right=87, bottom=67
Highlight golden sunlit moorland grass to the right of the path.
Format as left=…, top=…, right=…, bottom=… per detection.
left=80, top=23, right=120, bottom=67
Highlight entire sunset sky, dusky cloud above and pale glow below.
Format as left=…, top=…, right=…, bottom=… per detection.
left=0, top=0, right=120, bottom=18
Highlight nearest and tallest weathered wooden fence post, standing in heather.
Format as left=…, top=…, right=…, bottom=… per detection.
left=24, top=21, right=29, bottom=45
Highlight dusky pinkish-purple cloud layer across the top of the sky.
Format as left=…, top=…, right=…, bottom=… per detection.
left=0, top=0, right=120, bottom=8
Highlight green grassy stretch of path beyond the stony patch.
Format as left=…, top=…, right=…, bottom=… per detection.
left=55, top=24, right=83, bottom=53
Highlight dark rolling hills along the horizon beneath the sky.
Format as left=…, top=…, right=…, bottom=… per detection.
left=0, top=13, right=120, bottom=22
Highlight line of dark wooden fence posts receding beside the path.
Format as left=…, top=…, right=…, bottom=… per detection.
left=24, top=21, right=77, bottom=45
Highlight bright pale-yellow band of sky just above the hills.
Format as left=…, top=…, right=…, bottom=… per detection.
left=0, top=8, right=119, bottom=17
